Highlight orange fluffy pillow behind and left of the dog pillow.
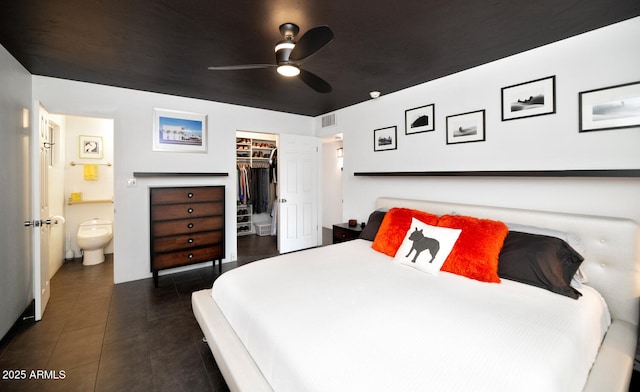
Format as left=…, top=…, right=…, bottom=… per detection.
left=371, top=208, right=438, bottom=257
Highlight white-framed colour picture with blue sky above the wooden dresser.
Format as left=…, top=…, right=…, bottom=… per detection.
left=153, top=109, right=207, bottom=153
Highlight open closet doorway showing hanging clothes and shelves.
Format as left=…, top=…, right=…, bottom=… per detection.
left=236, top=131, right=278, bottom=265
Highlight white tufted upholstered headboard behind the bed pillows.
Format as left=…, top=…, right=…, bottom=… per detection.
left=376, top=197, right=640, bottom=326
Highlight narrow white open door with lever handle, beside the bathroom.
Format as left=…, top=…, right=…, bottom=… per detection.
left=25, top=101, right=51, bottom=321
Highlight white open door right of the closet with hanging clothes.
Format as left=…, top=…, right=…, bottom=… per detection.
left=278, top=134, right=319, bottom=253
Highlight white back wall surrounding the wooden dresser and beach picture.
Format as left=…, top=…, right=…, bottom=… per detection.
left=33, top=76, right=313, bottom=283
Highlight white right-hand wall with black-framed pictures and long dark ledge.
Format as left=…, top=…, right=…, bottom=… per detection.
left=315, top=18, right=640, bottom=222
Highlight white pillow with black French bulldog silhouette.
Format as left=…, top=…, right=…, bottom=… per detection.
left=394, top=218, right=462, bottom=275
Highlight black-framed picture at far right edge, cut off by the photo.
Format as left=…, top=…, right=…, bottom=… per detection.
left=578, top=82, right=640, bottom=132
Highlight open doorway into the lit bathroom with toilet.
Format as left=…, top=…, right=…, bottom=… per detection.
left=49, top=114, right=114, bottom=275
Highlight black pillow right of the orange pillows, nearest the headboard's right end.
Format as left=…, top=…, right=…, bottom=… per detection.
left=498, top=231, right=584, bottom=299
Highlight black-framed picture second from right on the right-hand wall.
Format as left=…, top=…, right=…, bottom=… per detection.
left=502, top=76, right=556, bottom=121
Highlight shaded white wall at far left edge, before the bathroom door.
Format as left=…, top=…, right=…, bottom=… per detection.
left=0, top=46, right=33, bottom=338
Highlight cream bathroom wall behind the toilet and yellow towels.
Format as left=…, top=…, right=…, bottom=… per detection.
left=63, top=116, right=114, bottom=257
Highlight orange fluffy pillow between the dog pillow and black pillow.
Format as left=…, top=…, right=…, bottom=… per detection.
left=438, top=215, right=509, bottom=283
